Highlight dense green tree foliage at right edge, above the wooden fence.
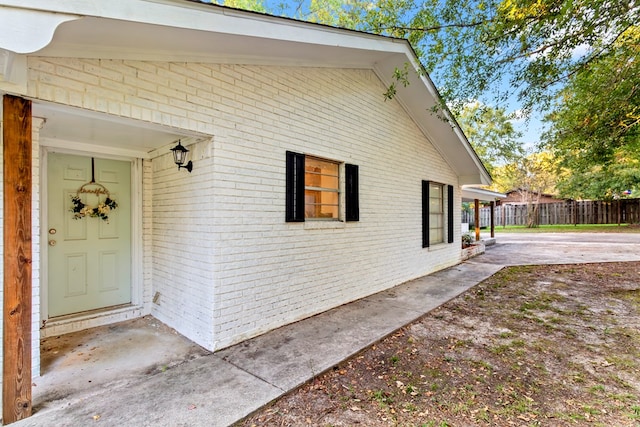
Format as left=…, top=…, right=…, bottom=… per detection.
left=545, top=27, right=640, bottom=199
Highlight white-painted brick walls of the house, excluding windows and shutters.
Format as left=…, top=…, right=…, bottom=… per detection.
left=28, top=57, right=460, bottom=350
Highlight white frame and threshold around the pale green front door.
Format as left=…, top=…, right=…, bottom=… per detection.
left=39, top=144, right=148, bottom=338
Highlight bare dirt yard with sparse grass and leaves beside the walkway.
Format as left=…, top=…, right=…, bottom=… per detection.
left=237, top=262, right=640, bottom=427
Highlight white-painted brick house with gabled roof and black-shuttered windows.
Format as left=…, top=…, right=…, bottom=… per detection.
left=0, top=0, right=490, bottom=402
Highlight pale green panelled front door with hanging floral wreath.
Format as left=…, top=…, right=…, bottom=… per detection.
left=47, top=153, right=131, bottom=318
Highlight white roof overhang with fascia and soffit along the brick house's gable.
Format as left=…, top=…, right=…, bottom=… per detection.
left=0, top=0, right=491, bottom=185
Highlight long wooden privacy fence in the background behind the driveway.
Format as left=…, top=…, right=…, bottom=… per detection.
left=462, top=199, right=640, bottom=227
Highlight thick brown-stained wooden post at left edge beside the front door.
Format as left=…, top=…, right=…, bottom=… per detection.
left=2, top=95, right=32, bottom=424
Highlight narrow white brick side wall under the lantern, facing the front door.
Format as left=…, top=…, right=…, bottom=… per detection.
left=152, top=144, right=214, bottom=349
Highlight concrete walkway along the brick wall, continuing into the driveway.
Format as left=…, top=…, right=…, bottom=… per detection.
left=13, top=234, right=640, bottom=427
